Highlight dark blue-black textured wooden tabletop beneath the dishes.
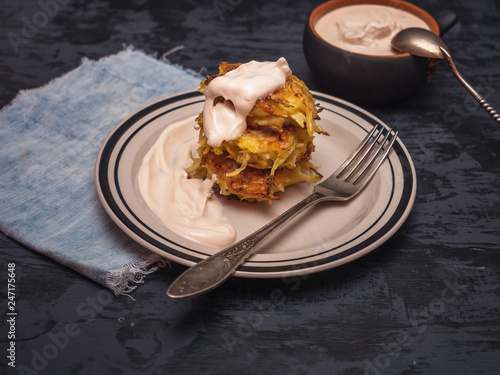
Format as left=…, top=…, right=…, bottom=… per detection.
left=0, top=0, right=500, bottom=375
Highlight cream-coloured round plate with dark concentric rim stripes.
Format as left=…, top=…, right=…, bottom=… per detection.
left=95, top=91, right=417, bottom=278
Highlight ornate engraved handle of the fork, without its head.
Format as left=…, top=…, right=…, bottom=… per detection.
left=167, top=191, right=331, bottom=298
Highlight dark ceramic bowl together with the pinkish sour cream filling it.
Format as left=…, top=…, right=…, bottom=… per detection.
left=303, top=0, right=457, bottom=104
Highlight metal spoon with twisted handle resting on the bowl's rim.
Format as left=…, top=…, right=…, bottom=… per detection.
left=392, top=27, right=500, bottom=123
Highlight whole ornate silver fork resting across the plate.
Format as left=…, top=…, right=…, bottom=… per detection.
left=167, top=124, right=398, bottom=298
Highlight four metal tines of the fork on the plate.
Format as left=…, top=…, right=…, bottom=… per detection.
left=335, top=124, right=398, bottom=185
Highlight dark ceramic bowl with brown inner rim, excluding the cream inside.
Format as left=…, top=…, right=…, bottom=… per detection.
left=303, top=0, right=457, bottom=104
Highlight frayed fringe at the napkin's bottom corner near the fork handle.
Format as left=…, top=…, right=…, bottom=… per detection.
left=104, top=253, right=170, bottom=299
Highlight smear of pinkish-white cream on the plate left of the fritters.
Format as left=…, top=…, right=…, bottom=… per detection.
left=138, top=117, right=236, bottom=248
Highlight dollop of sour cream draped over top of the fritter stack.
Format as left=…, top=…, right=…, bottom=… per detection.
left=203, top=57, right=292, bottom=147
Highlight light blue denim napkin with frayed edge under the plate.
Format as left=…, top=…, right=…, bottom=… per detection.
left=0, top=49, right=201, bottom=295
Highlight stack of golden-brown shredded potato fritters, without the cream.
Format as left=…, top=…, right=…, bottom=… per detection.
left=187, top=62, right=326, bottom=201
